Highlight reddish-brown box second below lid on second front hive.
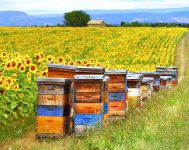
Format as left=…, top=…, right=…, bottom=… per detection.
left=75, top=92, right=102, bottom=103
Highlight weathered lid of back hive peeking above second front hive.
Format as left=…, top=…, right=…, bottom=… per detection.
left=76, top=66, right=104, bottom=73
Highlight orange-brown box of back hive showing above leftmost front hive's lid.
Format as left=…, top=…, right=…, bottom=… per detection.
left=48, top=70, right=75, bottom=78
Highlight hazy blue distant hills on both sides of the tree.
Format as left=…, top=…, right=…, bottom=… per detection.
left=0, top=8, right=189, bottom=26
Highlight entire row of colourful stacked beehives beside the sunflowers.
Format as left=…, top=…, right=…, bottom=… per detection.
left=36, top=64, right=178, bottom=137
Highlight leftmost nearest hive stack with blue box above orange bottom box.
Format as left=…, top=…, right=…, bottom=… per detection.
left=36, top=78, right=72, bottom=137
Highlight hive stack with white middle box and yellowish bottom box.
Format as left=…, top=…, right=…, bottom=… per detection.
left=127, top=73, right=143, bottom=111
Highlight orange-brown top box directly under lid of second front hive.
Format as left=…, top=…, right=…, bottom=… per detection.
left=75, top=82, right=102, bottom=92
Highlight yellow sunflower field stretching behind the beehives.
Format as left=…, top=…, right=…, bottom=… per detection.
left=0, top=27, right=187, bottom=126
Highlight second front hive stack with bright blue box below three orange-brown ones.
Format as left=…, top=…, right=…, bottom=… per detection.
left=74, top=75, right=104, bottom=133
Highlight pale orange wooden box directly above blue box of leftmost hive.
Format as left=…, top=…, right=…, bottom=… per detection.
left=38, top=94, right=72, bottom=106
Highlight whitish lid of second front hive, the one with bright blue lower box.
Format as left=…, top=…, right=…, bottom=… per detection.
left=74, top=75, right=105, bottom=80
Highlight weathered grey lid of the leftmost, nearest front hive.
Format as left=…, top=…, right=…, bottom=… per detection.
left=37, top=78, right=72, bottom=83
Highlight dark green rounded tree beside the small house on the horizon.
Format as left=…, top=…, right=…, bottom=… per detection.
left=64, top=10, right=91, bottom=27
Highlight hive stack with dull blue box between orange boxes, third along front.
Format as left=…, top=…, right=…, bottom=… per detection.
left=105, top=70, right=127, bottom=118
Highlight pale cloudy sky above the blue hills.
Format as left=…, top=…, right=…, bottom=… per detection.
left=0, top=0, right=189, bottom=14
